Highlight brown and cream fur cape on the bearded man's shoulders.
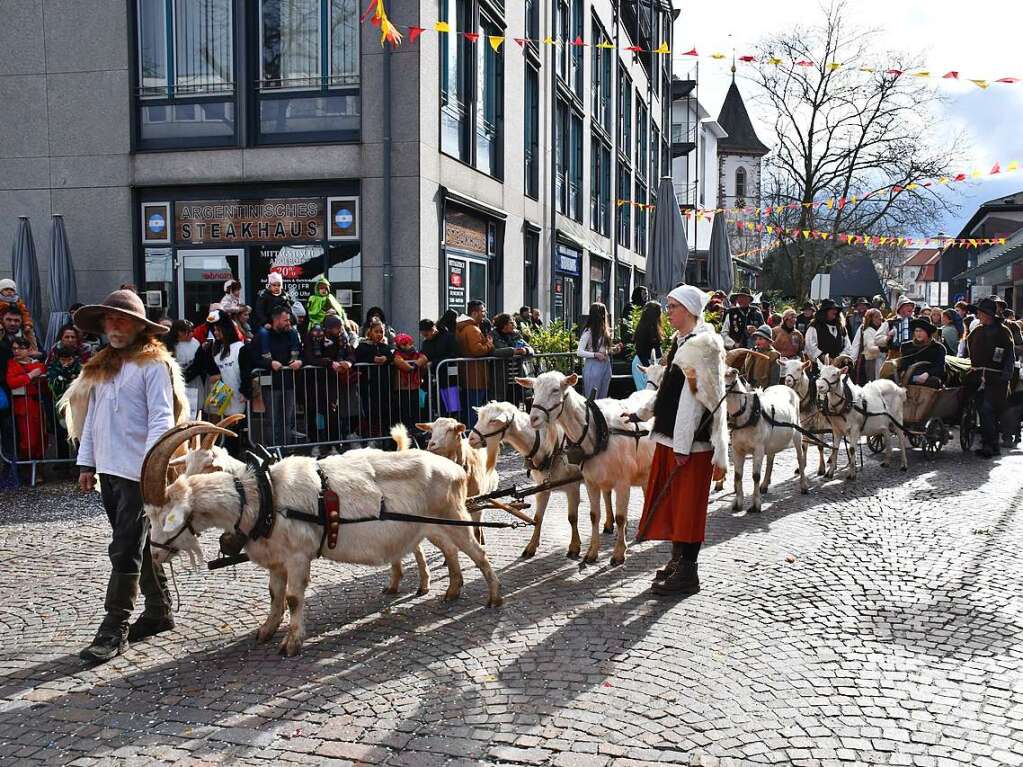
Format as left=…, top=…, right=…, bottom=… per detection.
left=57, top=339, right=191, bottom=442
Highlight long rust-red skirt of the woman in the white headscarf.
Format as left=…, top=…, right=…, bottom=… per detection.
left=636, top=445, right=714, bottom=543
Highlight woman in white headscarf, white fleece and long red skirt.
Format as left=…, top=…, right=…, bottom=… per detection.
left=636, top=285, right=723, bottom=595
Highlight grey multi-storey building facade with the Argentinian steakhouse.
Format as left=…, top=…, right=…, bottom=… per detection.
left=0, top=0, right=674, bottom=328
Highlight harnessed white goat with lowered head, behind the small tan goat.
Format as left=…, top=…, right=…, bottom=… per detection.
left=469, top=402, right=582, bottom=559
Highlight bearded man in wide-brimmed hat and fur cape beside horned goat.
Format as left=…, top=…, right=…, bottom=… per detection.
left=59, top=290, right=189, bottom=663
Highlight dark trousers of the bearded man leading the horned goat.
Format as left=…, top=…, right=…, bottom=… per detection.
left=99, top=475, right=171, bottom=618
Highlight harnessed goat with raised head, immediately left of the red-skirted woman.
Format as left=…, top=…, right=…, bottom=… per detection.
left=516, top=371, right=654, bottom=565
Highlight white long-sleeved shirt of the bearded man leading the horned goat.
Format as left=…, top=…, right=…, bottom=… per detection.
left=78, top=362, right=174, bottom=482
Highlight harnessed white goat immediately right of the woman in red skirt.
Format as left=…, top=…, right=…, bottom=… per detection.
left=724, top=367, right=808, bottom=513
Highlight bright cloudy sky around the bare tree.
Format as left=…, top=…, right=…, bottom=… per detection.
left=673, top=0, right=1023, bottom=236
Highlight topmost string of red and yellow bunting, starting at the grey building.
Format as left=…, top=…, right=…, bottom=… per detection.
left=361, top=0, right=1023, bottom=90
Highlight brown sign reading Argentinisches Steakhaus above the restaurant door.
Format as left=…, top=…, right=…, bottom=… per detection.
left=174, top=197, right=323, bottom=244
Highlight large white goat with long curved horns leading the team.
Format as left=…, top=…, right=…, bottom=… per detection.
left=141, top=424, right=502, bottom=656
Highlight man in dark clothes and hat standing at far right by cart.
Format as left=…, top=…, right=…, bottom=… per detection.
left=966, top=299, right=1016, bottom=458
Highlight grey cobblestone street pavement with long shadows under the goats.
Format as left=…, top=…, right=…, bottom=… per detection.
left=0, top=444, right=1023, bottom=767
